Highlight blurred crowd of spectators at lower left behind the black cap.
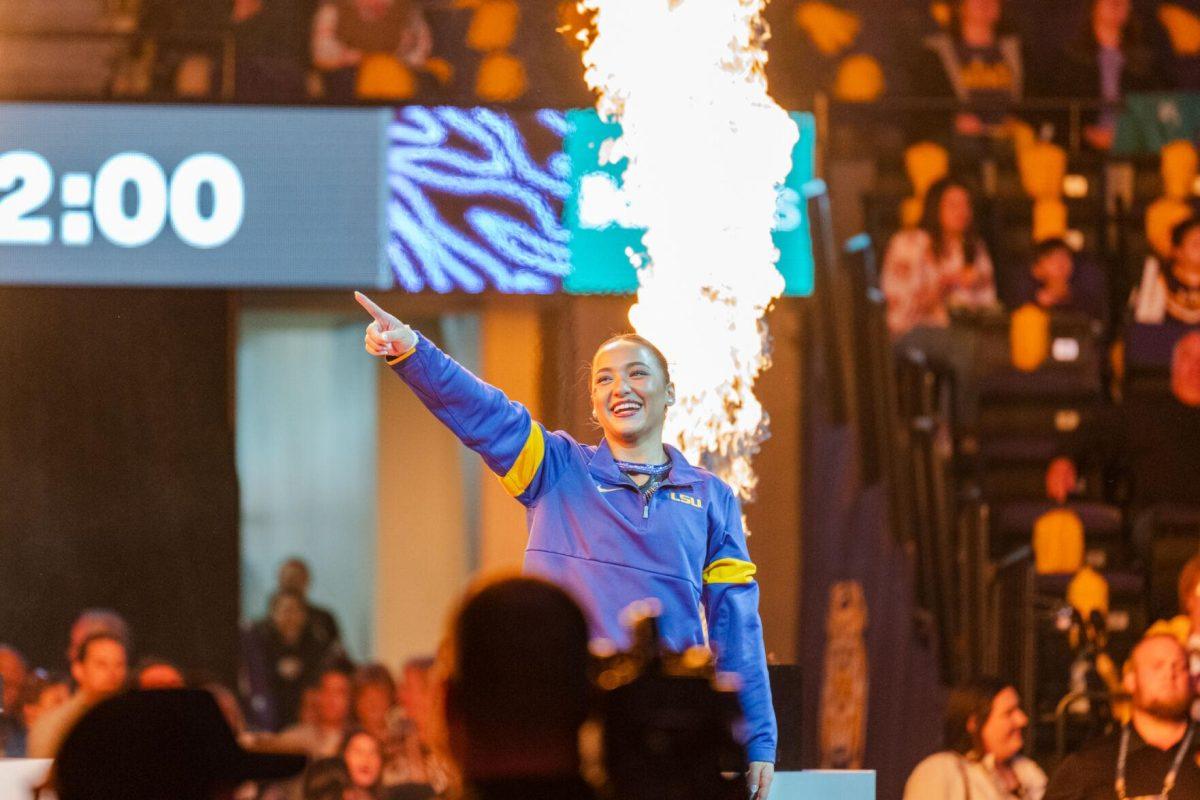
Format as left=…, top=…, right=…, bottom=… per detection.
left=0, top=559, right=454, bottom=800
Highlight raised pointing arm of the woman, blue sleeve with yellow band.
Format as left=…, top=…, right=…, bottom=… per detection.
left=354, top=293, right=569, bottom=505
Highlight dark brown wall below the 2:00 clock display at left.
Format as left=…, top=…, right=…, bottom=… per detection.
left=0, top=288, right=239, bottom=680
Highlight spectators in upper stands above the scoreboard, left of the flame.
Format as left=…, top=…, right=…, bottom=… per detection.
left=126, top=0, right=535, bottom=103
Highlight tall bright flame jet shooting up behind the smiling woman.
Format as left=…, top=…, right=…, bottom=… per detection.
left=578, top=0, right=799, bottom=500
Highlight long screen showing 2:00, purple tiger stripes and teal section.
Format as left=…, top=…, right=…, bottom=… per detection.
left=0, top=104, right=815, bottom=295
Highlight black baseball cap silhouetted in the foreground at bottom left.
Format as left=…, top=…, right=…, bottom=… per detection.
left=53, top=688, right=307, bottom=800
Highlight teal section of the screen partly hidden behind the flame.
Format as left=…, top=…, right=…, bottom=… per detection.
left=563, top=110, right=816, bottom=296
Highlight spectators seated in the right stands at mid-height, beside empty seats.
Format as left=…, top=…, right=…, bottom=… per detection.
left=880, top=170, right=1200, bottom=511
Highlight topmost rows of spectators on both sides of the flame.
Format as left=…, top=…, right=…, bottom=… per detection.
left=110, top=0, right=1200, bottom=112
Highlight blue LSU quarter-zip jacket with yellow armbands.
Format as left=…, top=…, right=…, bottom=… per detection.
left=389, top=337, right=776, bottom=762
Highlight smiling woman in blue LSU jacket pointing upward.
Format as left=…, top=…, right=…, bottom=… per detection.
left=355, top=294, right=776, bottom=800
